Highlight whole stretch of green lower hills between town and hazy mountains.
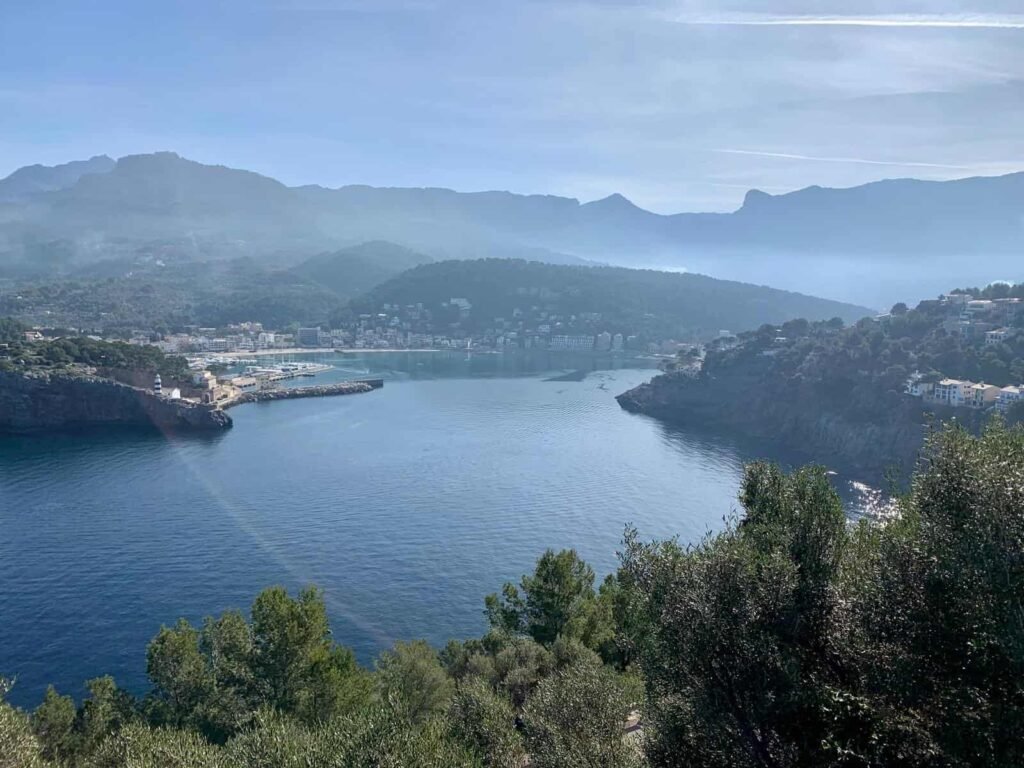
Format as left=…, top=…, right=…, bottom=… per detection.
left=0, top=253, right=870, bottom=339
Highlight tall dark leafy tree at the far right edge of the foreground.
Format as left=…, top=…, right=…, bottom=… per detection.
left=851, top=422, right=1024, bottom=766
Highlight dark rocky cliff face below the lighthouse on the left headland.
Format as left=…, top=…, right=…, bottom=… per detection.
left=0, top=372, right=231, bottom=432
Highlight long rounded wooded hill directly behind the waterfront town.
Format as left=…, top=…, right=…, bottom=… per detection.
left=339, top=259, right=869, bottom=339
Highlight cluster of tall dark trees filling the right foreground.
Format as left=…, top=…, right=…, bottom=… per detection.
left=621, top=424, right=1024, bottom=768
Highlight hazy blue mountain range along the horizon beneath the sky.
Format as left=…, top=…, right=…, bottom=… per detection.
left=0, top=153, right=1024, bottom=307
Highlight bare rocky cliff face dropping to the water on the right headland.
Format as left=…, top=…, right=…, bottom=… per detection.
left=616, top=374, right=937, bottom=478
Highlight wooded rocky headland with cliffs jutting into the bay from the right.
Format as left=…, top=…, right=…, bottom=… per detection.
left=618, top=285, right=1024, bottom=474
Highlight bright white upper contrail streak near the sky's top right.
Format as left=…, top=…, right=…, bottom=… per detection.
left=673, top=14, right=1024, bottom=30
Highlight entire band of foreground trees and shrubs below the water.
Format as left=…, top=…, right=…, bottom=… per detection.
left=0, top=422, right=1024, bottom=768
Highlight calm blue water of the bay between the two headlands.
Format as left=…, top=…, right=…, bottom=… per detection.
left=0, top=353, right=880, bottom=705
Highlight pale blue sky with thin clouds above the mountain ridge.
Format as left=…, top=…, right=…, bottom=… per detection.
left=0, top=0, right=1024, bottom=213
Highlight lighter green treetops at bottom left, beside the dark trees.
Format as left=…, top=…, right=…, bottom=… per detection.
left=0, top=552, right=640, bottom=768
